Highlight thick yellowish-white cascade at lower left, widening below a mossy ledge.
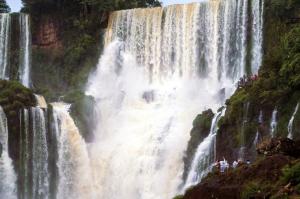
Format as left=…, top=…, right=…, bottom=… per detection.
left=52, top=103, right=95, bottom=199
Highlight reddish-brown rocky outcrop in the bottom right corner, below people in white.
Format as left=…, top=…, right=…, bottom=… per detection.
left=177, top=138, right=300, bottom=199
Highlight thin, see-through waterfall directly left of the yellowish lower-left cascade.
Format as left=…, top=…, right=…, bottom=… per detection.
left=31, top=107, right=49, bottom=199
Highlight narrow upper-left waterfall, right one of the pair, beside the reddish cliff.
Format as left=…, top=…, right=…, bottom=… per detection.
left=19, top=13, right=31, bottom=87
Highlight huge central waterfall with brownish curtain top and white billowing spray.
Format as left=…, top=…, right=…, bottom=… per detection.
left=86, top=0, right=263, bottom=199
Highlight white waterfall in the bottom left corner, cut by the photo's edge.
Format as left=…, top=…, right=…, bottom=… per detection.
left=0, top=106, right=17, bottom=199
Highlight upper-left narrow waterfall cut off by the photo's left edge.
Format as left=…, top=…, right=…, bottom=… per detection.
left=0, top=14, right=10, bottom=79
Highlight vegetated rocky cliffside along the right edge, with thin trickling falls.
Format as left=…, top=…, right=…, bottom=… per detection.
left=178, top=0, right=300, bottom=199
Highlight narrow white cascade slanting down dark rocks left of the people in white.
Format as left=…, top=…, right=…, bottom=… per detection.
left=183, top=110, right=225, bottom=190
